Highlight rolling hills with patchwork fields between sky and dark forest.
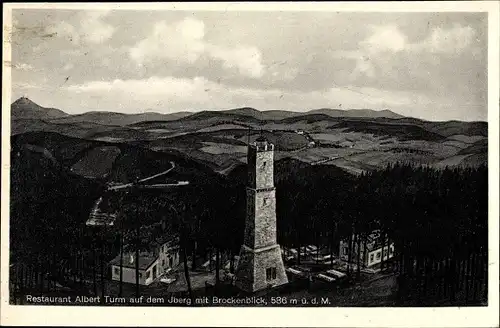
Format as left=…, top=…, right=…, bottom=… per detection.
left=11, top=99, right=488, bottom=176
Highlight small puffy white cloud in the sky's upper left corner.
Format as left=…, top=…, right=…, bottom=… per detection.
left=46, top=10, right=115, bottom=46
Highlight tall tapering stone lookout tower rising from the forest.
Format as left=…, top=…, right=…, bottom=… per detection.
left=236, top=137, right=288, bottom=293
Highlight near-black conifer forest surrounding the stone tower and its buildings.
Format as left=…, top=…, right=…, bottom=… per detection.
left=10, top=142, right=488, bottom=306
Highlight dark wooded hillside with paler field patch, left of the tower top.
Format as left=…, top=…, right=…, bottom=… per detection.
left=11, top=132, right=220, bottom=183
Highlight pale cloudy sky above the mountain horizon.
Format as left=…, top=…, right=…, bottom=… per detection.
left=10, top=9, right=488, bottom=121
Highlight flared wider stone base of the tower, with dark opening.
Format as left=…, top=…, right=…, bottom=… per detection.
left=235, top=244, right=288, bottom=293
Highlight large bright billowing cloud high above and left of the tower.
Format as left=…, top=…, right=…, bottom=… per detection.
left=129, top=18, right=265, bottom=78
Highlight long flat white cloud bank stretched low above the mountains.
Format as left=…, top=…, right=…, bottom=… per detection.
left=65, top=76, right=432, bottom=111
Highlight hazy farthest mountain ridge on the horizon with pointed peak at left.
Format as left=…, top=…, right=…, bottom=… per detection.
left=11, top=97, right=404, bottom=126
